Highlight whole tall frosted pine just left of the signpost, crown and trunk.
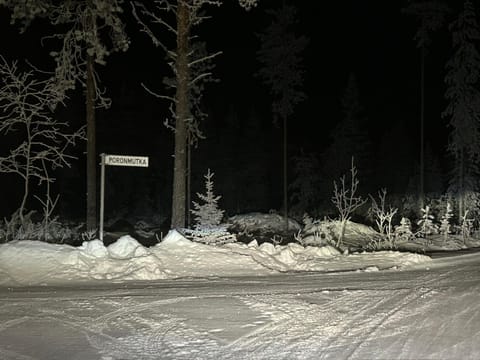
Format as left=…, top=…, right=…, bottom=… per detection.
left=0, top=0, right=129, bottom=230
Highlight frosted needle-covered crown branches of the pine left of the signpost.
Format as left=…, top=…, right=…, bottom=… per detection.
left=0, top=0, right=129, bottom=108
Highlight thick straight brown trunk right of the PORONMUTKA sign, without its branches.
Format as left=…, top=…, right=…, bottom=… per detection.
left=171, top=1, right=189, bottom=228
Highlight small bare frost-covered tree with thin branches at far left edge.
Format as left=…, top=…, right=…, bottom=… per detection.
left=0, top=57, right=84, bottom=229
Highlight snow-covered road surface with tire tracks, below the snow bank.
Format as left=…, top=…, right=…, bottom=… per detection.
left=0, top=253, right=480, bottom=360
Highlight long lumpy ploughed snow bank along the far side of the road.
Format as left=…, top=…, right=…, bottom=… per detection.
left=0, top=230, right=430, bottom=286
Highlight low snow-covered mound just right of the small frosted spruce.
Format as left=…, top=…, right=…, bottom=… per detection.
left=228, top=212, right=302, bottom=233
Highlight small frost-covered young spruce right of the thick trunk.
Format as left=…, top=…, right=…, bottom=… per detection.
left=191, top=169, right=224, bottom=229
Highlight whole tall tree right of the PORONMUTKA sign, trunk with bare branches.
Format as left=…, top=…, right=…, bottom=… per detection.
left=132, top=0, right=257, bottom=228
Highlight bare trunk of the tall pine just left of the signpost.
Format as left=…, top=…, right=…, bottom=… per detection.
left=86, top=51, right=97, bottom=231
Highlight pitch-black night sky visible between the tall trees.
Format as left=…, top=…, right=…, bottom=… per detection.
left=0, top=0, right=478, bottom=225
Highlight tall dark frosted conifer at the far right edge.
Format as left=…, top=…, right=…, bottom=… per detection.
left=443, top=0, right=480, bottom=219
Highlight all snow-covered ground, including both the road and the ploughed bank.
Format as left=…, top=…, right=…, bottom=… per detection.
left=0, top=226, right=480, bottom=360
